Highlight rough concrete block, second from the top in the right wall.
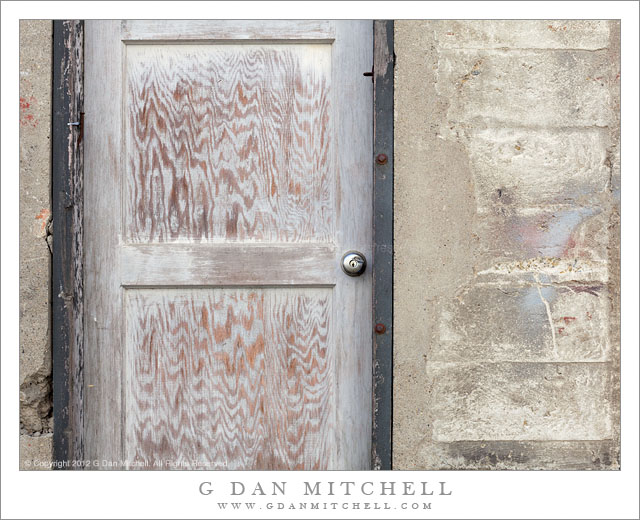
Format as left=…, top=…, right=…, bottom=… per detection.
left=436, top=50, right=620, bottom=128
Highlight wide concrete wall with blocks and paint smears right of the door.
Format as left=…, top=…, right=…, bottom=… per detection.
left=393, top=20, right=620, bottom=469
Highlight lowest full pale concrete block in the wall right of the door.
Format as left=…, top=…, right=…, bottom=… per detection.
left=427, top=362, right=613, bottom=442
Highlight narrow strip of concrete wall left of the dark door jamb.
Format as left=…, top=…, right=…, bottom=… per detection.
left=19, top=20, right=53, bottom=468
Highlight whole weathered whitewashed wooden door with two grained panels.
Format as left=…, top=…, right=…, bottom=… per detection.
left=84, top=20, right=372, bottom=469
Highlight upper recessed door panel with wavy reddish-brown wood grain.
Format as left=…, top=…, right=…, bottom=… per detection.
left=125, top=44, right=334, bottom=242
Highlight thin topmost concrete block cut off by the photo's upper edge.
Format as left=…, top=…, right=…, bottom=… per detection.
left=433, top=20, right=610, bottom=50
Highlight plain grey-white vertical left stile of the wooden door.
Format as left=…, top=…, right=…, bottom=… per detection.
left=84, top=20, right=124, bottom=468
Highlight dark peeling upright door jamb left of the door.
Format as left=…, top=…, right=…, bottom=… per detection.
left=51, top=20, right=84, bottom=469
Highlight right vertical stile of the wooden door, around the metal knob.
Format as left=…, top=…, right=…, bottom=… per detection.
left=332, top=20, right=382, bottom=470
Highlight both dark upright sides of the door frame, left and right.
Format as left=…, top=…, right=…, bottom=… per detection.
left=51, top=20, right=395, bottom=469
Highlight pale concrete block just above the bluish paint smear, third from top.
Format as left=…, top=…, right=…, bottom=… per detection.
left=467, top=128, right=611, bottom=211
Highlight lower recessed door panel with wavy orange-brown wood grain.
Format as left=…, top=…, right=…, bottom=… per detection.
left=125, top=289, right=334, bottom=469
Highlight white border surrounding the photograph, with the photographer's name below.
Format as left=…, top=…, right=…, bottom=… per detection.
left=1, top=1, right=639, bottom=518
